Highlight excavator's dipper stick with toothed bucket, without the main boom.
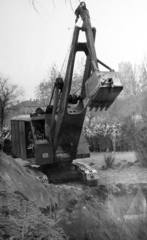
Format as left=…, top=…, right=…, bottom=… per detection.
left=75, top=2, right=123, bottom=110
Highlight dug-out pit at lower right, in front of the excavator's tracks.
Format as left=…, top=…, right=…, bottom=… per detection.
left=56, top=184, right=147, bottom=240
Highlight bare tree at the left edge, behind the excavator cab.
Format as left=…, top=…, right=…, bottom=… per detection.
left=0, top=74, right=23, bottom=130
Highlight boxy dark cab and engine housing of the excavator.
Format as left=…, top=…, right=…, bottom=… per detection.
left=11, top=115, right=54, bottom=165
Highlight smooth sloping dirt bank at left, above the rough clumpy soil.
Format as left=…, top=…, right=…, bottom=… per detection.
left=0, top=152, right=55, bottom=208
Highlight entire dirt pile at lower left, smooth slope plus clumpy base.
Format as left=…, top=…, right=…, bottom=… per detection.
left=0, top=152, right=67, bottom=240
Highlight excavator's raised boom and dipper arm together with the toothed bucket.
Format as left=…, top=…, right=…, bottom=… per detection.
left=47, top=2, right=123, bottom=161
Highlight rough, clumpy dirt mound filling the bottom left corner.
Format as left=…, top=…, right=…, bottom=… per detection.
left=0, top=191, right=65, bottom=240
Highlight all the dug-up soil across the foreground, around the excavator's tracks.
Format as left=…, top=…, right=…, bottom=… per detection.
left=0, top=152, right=147, bottom=240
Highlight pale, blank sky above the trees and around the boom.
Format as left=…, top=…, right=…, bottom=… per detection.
left=0, top=0, right=147, bottom=99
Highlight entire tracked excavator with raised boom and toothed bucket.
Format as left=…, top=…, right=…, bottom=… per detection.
left=11, top=2, right=123, bottom=185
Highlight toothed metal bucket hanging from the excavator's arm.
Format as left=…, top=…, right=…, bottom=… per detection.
left=84, top=70, right=123, bottom=110
